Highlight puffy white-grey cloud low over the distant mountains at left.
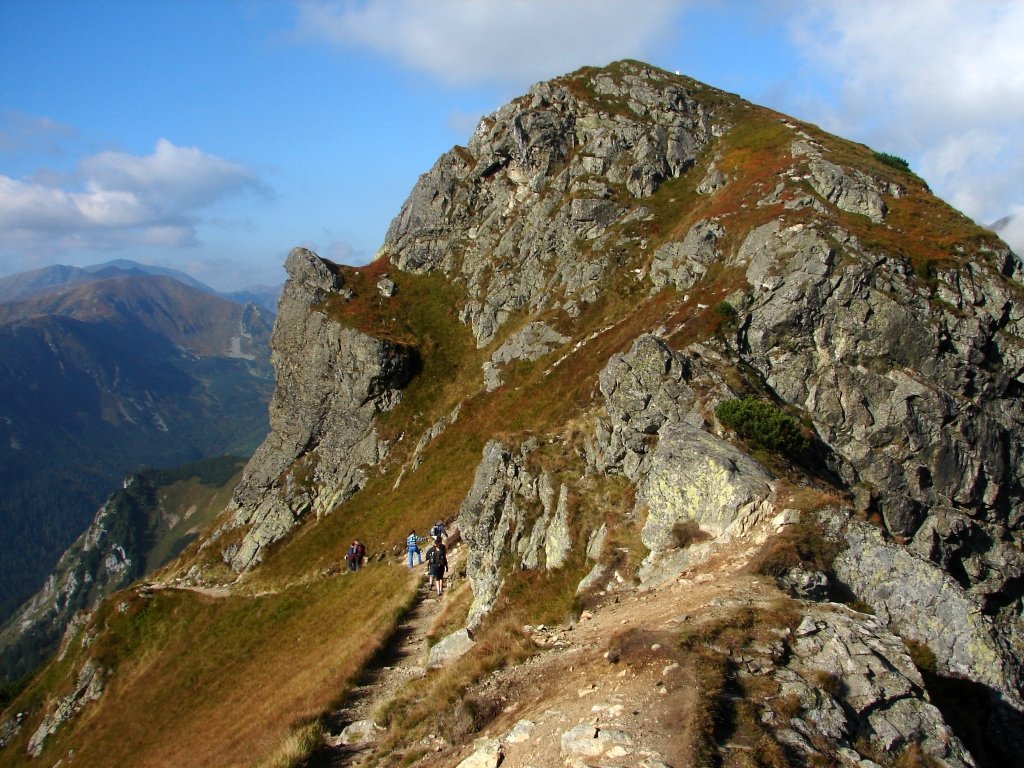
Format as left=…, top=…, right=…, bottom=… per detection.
left=0, top=138, right=263, bottom=256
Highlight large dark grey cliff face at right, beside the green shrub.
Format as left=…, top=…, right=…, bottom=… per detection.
left=735, top=214, right=1024, bottom=573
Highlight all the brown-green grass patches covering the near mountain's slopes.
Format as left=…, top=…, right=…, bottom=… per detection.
left=0, top=66, right=1011, bottom=768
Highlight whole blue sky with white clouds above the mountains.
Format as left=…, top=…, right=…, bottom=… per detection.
left=0, top=0, right=1024, bottom=290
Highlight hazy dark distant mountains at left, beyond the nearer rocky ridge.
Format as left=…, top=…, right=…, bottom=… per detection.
left=0, top=261, right=273, bottom=618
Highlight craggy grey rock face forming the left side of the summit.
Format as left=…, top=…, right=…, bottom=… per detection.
left=384, top=62, right=722, bottom=346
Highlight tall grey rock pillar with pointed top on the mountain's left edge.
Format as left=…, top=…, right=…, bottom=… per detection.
left=221, top=248, right=412, bottom=571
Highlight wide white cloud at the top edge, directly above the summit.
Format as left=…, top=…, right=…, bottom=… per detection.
left=299, top=0, right=683, bottom=85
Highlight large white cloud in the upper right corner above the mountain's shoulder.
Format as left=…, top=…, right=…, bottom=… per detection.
left=794, top=0, right=1024, bottom=221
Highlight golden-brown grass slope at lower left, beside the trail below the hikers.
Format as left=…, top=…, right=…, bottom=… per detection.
left=0, top=567, right=415, bottom=768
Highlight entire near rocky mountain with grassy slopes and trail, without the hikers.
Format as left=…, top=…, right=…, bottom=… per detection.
left=0, top=61, right=1024, bottom=768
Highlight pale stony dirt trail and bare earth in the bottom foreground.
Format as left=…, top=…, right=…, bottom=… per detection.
left=308, top=536, right=778, bottom=768
